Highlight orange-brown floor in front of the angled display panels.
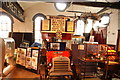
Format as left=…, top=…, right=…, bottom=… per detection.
left=3, top=67, right=100, bottom=80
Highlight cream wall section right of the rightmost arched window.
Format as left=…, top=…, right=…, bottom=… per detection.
left=107, top=9, right=118, bottom=45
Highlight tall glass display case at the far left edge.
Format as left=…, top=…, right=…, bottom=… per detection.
left=0, top=38, right=15, bottom=77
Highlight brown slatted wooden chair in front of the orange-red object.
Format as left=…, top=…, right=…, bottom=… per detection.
left=48, top=56, right=73, bottom=78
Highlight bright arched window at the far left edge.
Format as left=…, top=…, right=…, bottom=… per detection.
left=0, top=13, right=12, bottom=38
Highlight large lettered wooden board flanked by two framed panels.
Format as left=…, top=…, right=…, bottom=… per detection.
left=41, top=15, right=74, bottom=40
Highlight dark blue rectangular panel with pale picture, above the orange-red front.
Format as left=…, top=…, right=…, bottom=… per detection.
left=47, top=42, right=66, bottom=51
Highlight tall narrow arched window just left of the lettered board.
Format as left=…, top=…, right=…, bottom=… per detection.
left=33, top=13, right=46, bottom=44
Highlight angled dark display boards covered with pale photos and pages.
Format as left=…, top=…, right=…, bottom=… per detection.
left=16, top=47, right=41, bottom=74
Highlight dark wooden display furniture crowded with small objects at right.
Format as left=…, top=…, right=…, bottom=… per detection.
left=72, top=43, right=119, bottom=79
